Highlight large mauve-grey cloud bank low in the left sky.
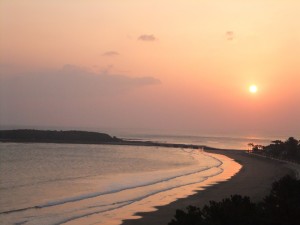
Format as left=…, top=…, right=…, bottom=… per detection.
left=0, top=65, right=160, bottom=100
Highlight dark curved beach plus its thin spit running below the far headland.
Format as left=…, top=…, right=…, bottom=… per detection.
left=0, top=134, right=300, bottom=225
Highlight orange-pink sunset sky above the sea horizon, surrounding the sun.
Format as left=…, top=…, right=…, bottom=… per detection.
left=0, top=0, right=300, bottom=136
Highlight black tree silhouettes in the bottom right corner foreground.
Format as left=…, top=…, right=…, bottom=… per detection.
left=169, top=176, right=300, bottom=225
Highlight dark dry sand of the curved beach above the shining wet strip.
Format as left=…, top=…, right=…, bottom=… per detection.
left=122, top=150, right=293, bottom=225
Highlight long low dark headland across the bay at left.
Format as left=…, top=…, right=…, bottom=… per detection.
left=0, top=130, right=121, bottom=143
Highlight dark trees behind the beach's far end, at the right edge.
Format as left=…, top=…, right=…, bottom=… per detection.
left=248, top=137, right=300, bottom=163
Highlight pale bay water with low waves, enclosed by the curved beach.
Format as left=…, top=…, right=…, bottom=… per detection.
left=0, top=143, right=239, bottom=225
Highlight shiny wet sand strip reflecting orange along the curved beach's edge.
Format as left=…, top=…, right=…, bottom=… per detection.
left=52, top=149, right=241, bottom=225
